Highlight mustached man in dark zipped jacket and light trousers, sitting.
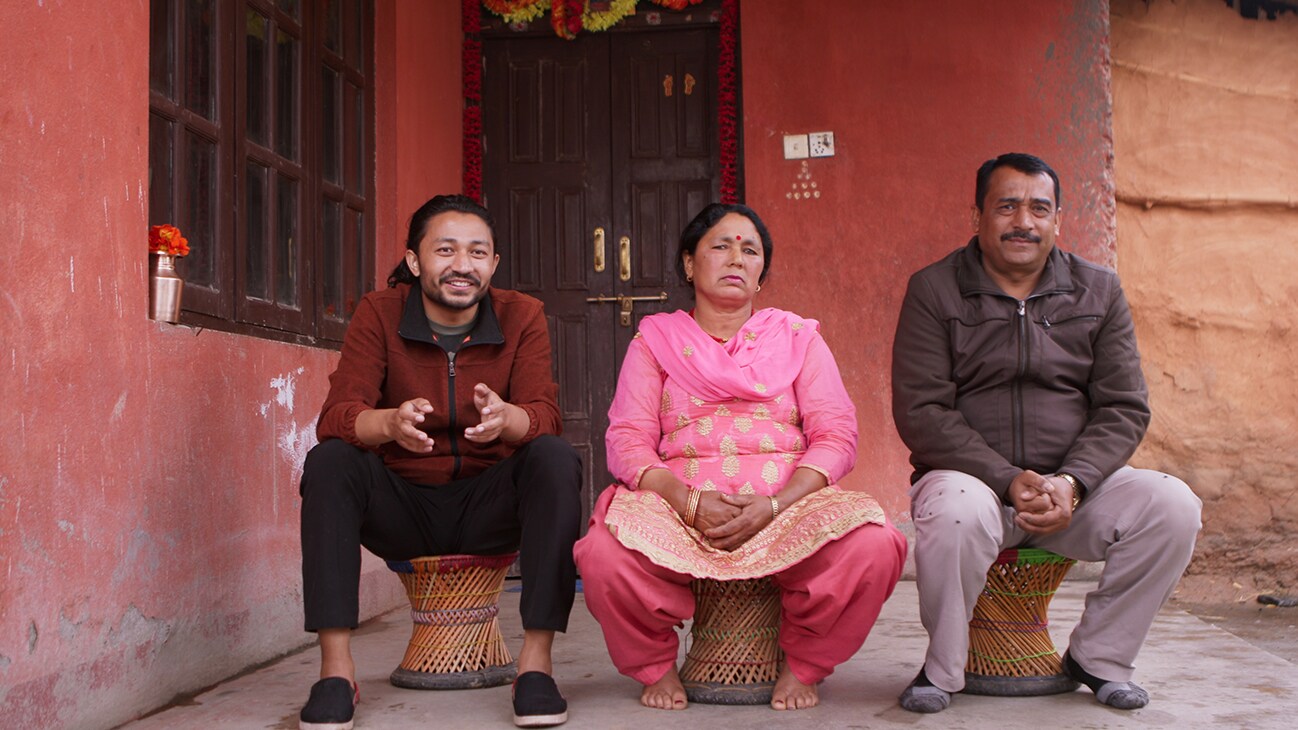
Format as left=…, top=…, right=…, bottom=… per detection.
left=892, top=153, right=1201, bottom=712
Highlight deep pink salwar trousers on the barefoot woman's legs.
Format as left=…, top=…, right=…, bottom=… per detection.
left=574, top=488, right=906, bottom=685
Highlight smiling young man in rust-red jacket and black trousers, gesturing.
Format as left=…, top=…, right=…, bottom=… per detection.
left=300, top=195, right=582, bottom=730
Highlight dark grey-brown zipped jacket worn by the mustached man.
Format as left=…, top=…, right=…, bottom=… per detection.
left=892, top=236, right=1150, bottom=499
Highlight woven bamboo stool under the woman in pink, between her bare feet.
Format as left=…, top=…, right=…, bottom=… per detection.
left=680, top=578, right=783, bottom=704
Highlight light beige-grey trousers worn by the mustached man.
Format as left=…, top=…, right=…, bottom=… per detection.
left=910, top=466, right=1202, bottom=692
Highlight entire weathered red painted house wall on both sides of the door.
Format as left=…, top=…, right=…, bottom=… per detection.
left=0, top=0, right=1114, bottom=727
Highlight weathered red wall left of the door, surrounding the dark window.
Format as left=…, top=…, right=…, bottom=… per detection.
left=0, top=0, right=461, bottom=727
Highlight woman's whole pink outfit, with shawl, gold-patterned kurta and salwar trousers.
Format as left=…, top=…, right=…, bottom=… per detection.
left=575, top=309, right=906, bottom=683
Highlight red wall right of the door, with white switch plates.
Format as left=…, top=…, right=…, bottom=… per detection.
left=740, top=0, right=1114, bottom=514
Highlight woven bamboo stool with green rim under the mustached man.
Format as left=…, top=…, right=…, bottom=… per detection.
left=964, top=548, right=1077, bottom=696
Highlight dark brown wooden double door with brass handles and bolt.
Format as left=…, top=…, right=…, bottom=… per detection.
left=483, top=26, right=720, bottom=526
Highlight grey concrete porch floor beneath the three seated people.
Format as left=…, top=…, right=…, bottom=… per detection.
left=123, top=581, right=1298, bottom=730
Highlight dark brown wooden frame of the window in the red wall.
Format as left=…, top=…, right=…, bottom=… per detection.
left=149, top=0, right=375, bottom=348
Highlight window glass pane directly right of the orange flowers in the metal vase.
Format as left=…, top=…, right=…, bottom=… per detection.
left=184, top=132, right=219, bottom=287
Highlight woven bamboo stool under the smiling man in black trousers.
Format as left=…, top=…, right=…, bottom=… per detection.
left=388, top=552, right=518, bottom=690
